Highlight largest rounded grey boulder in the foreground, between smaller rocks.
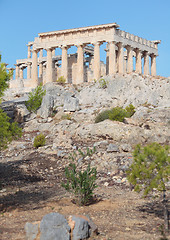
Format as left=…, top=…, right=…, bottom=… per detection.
left=40, top=213, right=70, bottom=240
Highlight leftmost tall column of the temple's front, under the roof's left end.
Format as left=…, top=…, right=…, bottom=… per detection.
left=31, top=49, right=38, bottom=88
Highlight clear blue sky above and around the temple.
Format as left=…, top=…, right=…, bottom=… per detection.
left=0, top=0, right=170, bottom=77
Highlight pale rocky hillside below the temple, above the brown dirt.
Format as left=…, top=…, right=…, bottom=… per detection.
left=0, top=74, right=170, bottom=239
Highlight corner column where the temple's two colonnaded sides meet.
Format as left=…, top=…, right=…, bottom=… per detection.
left=109, top=42, right=116, bottom=75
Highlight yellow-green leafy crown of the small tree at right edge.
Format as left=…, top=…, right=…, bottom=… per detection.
left=127, top=143, right=170, bottom=196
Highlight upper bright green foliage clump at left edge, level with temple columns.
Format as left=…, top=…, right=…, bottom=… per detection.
left=0, top=55, right=12, bottom=97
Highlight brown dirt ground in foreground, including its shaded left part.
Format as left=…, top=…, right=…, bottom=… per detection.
left=0, top=151, right=169, bottom=240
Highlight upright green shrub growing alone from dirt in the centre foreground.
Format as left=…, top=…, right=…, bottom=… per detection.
left=61, top=148, right=97, bottom=205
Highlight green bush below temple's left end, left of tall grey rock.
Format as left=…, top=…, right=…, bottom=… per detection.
left=26, top=85, right=46, bottom=113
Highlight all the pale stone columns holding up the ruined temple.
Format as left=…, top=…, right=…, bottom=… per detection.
left=16, top=41, right=156, bottom=87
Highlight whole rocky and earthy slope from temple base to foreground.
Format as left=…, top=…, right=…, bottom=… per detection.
left=0, top=74, right=170, bottom=240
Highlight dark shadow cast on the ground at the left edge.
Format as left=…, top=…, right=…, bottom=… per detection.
left=0, top=153, right=64, bottom=211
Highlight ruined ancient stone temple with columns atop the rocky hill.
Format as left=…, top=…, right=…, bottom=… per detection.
left=10, top=23, right=160, bottom=88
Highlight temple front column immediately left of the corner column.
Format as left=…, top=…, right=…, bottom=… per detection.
left=93, top=42, right=100, bottom=80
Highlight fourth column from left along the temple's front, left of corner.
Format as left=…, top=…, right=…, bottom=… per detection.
left=76, top=45, right=84, bottom=84
